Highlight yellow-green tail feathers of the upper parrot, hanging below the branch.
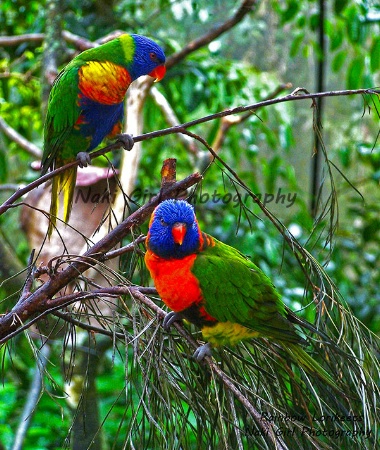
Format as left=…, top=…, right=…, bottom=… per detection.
left=48, top=167, right=77, bottom=238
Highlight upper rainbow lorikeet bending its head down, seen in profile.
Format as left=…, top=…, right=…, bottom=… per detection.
left=42, top=34, right=166, bottom=236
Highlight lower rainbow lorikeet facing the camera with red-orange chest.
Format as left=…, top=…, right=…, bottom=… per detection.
left=145, top=200, right=336, bottom=388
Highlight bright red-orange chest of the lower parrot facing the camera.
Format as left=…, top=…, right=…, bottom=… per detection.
left=145, top=250, right=202, bottom=312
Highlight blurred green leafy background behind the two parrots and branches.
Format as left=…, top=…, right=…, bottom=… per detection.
left=0, top=0, right=380, bottom=449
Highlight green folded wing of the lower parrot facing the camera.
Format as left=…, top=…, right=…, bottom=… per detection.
left=192, top=239, right=301, bottom=343
